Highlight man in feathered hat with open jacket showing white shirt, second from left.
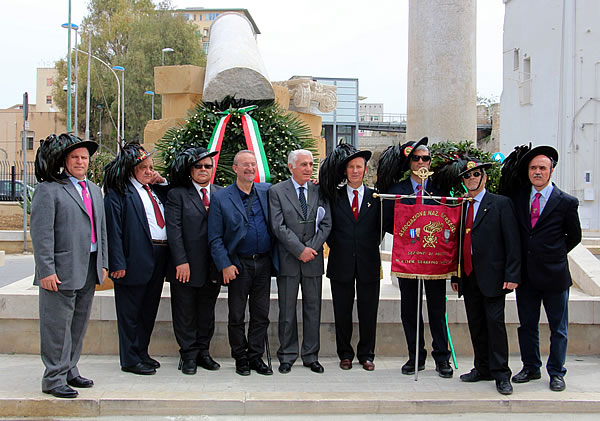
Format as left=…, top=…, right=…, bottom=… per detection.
left=104, top=143, right=169, bottom=375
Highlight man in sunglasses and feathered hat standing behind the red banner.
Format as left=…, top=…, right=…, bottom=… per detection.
left=377, top=137, right=453, bottom=378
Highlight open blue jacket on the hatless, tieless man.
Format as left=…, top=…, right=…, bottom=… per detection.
left=208, top=183, right=279, bottom=271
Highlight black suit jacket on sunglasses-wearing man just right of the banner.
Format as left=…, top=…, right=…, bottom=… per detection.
left=459, top=192, right=521, bottom=297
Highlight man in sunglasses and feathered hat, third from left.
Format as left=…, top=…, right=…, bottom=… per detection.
left=165, top=147, right=221, bottom=374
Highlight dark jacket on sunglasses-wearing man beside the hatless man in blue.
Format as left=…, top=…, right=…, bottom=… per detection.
left=165, top=184, right=222, bottom=287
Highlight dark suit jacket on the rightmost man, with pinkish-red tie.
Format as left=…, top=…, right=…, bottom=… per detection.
left=513, top=184, right=581, bottom=292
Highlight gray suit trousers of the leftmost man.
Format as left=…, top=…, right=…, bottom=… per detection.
left=39, top=249, right=98, bottom=391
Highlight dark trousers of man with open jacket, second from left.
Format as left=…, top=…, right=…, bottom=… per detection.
left=115, top=245, right=169, bottom=367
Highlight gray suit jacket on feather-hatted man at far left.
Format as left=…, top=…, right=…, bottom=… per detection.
left=31, top=178, right=108, bottom=290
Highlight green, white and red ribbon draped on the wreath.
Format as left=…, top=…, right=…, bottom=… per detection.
left=208, top=105, right=271, bottom=183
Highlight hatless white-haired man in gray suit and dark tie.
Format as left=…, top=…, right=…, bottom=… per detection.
left=269, top=149, right=331, bottom=374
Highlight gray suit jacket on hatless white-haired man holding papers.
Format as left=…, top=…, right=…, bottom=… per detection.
left=269, top=180, right=331, bottom=276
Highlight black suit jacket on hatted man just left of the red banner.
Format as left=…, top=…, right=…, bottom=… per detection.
left=327, top=186, right=381, bottom=283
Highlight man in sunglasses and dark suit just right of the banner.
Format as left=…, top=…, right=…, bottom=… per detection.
left=452, top=159, right=521, bottom=395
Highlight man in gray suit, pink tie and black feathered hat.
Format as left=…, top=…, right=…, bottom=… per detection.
left=31, top=134, right=108, bottom=398
